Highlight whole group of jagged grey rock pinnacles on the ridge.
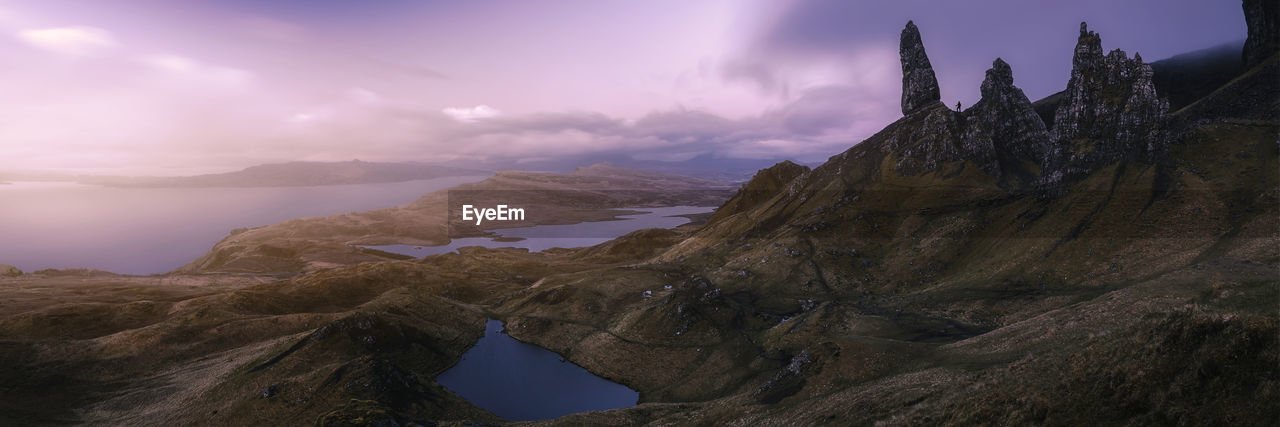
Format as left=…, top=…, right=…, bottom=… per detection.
left=884, top=22, right=1169, bottom=192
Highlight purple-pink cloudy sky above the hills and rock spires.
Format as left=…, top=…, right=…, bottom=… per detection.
left=0, top=0, right=1245, bottom=175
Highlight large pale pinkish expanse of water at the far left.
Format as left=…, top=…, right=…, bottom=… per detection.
left=0, top=176, right=488, bottom=275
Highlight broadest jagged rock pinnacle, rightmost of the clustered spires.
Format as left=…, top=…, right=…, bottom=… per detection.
left=1042, top=23, right=1169, bottom=185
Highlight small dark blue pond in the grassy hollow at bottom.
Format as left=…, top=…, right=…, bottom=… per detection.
left=436, top=320, right=640, bottom=421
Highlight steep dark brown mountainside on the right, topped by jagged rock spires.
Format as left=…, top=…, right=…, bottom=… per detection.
left=486, top=12, right=1280, bottom=424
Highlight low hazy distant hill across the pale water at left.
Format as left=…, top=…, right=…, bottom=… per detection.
left=79, top=160, right=489, bottom=188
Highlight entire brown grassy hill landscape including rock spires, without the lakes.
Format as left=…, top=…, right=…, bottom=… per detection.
left=0, top=0, right=1280, bottom=426
